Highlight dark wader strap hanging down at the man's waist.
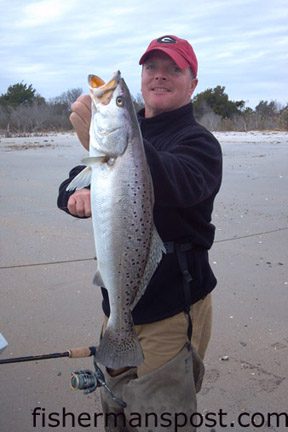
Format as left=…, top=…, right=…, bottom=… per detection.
left=175, top=244, right=192, bottom=343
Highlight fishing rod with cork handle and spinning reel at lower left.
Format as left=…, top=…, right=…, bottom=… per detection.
left=0, top=333, right=126, bottom=408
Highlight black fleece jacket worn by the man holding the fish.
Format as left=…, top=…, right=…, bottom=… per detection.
left=58, top=103, right=222, bottom=324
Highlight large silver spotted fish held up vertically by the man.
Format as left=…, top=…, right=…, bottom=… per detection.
left=67, top=71, right=165, bottom=369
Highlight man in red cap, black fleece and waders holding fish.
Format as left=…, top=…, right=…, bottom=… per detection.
left=58, top=35, right=222, bottom=431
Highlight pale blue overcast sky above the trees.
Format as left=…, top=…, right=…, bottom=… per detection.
left=0, top=0, right=288, bottom=108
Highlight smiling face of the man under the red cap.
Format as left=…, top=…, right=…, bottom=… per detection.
left=141, top=51, right=198, bottom=118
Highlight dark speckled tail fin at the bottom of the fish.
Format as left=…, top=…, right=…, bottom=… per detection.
left=96, top=326, right=144, bottom=369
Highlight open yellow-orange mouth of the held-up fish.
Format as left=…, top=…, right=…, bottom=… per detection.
left=88, top=71, right=121, bottom=105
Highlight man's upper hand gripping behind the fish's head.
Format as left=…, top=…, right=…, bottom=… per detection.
left=70, top=95, right=91, bottom=150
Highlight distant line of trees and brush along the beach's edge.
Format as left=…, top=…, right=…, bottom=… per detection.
left=0, top=83, right=288, bottom=136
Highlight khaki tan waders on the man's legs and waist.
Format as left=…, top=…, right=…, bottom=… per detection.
left=101, top=294, right=212, bottom=432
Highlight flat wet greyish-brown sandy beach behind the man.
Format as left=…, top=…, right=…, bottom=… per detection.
left=0, top=132, right=288, bottom=432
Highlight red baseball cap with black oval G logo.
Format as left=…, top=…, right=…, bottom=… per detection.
left=139, top=35, right=198, bottom=78
